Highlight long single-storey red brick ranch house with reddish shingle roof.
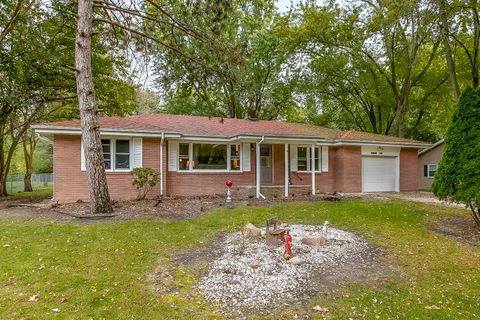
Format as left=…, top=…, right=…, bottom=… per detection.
left=34, top=115, right=430, bottom=201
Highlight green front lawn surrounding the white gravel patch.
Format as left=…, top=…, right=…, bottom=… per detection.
left=0, top=200, right=480, bottom=319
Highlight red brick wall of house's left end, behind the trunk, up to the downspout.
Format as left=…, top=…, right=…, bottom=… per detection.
left=53, top=135, right=160, bottom=201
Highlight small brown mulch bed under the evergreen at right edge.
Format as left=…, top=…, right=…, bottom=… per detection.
left=430, top=217, right=480, bottom=246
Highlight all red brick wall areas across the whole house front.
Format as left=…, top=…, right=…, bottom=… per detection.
left=53, top=135, right=418, bottom=201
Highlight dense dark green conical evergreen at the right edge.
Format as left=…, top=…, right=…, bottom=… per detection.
left=432, top=88, right=480, bottom=227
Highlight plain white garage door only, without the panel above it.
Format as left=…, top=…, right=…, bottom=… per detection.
left=362, top=157, right=397, bottom=192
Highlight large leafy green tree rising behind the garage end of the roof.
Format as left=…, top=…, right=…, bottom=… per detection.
left=283, top=0, right=452, bottom=140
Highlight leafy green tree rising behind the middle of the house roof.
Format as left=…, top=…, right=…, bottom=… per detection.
left=151, top=0, right=293, bottom=119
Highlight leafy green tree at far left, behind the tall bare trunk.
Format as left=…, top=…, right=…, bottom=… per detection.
left=0, top=0, right=137, bottom=196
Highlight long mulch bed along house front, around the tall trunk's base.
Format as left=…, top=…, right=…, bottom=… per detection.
left=0, top=194, right=350, bottom=224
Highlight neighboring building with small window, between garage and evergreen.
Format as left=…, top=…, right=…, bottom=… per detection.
left=418, top=139, right=445, bottom=190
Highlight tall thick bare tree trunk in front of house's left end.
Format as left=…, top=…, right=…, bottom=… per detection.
left=75, top=0, right=113, bottom=213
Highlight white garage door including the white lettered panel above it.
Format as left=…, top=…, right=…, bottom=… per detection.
left=362, top=147, right=400, bottom=192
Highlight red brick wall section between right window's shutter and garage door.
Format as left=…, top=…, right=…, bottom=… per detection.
left=335, top=146, right=362, bottom=192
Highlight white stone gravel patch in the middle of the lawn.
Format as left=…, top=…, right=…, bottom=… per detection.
left=198, top=225, right=369, bottom=308
